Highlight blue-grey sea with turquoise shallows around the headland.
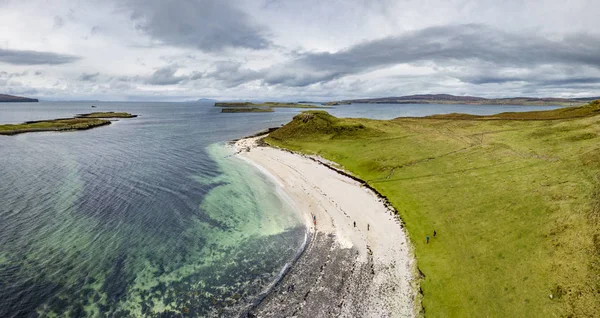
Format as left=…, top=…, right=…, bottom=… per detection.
left=0, top=102, right=556, bottom=317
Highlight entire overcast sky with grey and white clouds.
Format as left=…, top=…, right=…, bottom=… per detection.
left=0, top=0, right=600, bottom=101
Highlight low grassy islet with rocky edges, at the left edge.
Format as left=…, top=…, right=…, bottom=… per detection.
left=0, top=112, right=137, bottom=136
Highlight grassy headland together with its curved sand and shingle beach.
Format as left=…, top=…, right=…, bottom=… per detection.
left=238, top=101, right=600, bottom=317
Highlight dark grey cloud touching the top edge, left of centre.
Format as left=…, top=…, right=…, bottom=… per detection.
left=128, top=0, right=270, bottom=52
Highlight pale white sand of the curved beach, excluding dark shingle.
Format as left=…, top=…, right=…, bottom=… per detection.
left=235, top=136, right=416, bottom=317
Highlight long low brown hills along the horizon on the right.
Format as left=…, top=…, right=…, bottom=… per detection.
left=325, top=94, right=600, bottom=106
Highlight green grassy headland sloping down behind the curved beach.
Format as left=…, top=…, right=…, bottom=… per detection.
left=267, top=103, right=600, bottom=317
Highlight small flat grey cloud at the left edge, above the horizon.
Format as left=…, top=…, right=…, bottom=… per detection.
left=0, top=49, right=80, bottom=65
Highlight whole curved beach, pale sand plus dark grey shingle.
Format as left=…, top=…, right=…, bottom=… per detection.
left=232, top=133, right=420, bottom=317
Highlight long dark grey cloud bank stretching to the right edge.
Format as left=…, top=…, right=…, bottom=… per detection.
left=265, top=24, right=600, bottom=86
